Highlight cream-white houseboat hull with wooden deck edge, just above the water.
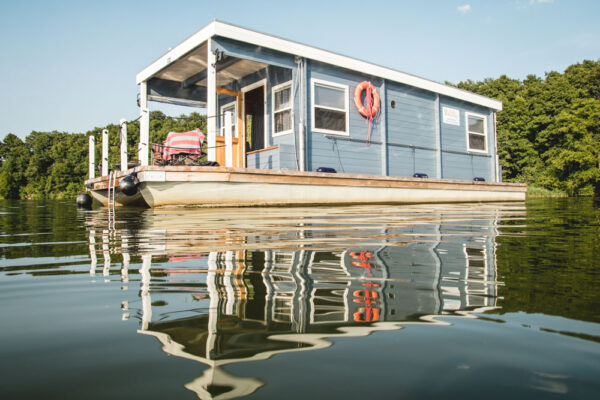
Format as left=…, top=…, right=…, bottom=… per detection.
left=86, top=166, right=527, bottom=207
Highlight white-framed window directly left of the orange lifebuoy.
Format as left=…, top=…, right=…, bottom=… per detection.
left=311, top=79, right=349, bottom=135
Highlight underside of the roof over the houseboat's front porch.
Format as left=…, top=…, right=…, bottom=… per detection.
left=155, top=42, right=267, bottom=86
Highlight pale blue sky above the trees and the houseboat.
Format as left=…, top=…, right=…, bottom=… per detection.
left=0, top=0, right=600, bottom=138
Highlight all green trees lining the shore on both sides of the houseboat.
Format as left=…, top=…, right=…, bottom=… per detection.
left=0, top=60, right=600, bottom=200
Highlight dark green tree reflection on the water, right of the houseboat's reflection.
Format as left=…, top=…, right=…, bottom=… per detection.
left=496, top=198, right=600, bottom=322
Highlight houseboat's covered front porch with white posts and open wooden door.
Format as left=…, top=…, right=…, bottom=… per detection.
left=136, top=21, right=306, bottom=171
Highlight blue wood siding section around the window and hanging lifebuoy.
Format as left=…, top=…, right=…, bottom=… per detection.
left=306, top=61, right=385, bottom=175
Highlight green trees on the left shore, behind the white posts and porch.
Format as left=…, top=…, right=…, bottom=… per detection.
left=0, top=111, right=206, bottom=200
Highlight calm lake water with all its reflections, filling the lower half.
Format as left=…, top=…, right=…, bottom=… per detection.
left=0, top=199, right=600, bottom=399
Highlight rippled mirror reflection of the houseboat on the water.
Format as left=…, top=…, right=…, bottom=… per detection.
left=86, top=205, right=510, bottom=399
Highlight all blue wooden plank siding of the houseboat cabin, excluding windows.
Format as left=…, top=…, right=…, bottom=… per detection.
left=204, top=38, right=496, bottom=181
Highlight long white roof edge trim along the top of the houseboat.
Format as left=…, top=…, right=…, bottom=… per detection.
left=136, top=20, right=502, bottom=111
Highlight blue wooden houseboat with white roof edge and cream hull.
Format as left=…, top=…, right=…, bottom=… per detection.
left=86, top=20, right=526, bottom=207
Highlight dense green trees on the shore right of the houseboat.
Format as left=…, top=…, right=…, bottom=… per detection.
left=457, top=61, right=600, bottom=196
